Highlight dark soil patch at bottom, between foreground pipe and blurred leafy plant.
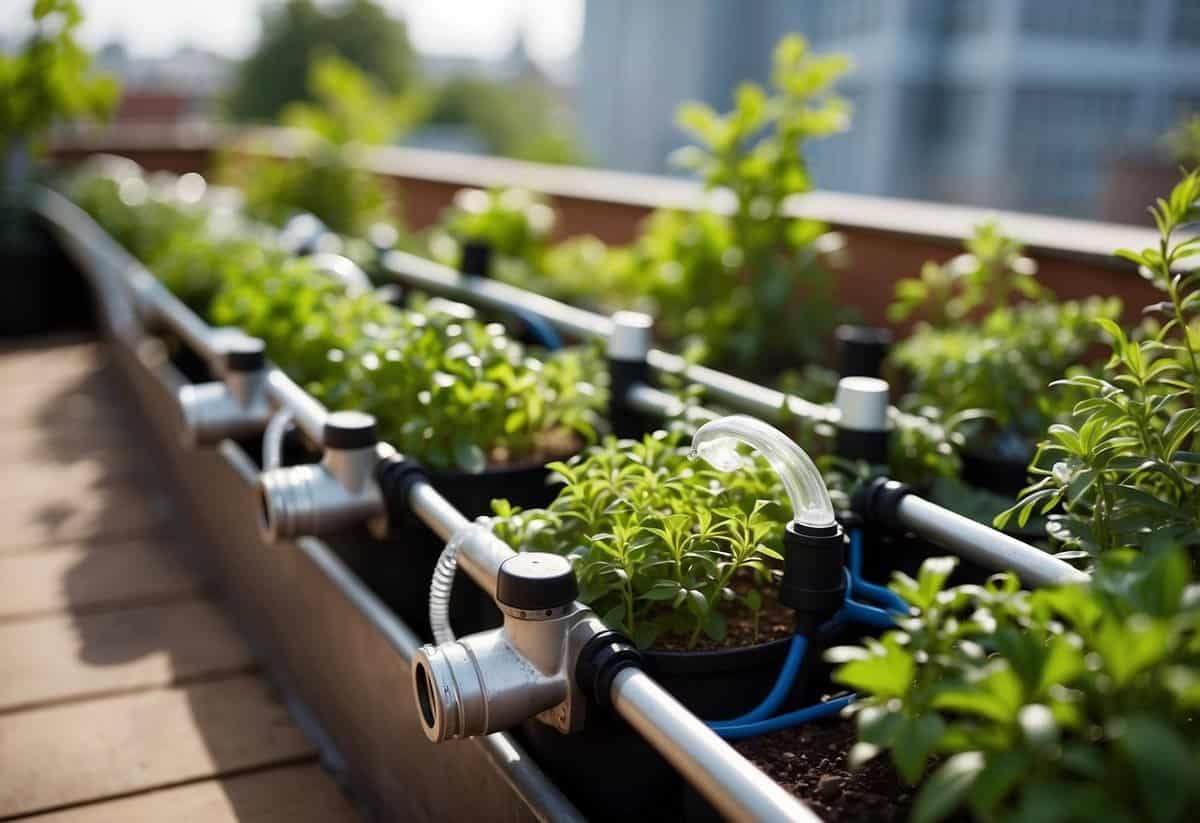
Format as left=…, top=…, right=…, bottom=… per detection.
left=734, top=719, right=913, bottom=823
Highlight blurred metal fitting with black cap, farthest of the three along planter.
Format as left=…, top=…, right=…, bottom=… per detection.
left=176, top=336, right=271, bottom=449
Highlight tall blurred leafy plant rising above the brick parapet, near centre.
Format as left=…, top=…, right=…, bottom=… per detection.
left=444, top=36, right=848, bottom=368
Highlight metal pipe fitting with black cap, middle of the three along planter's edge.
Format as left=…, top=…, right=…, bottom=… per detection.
left=258, top=412, right=390, bottom=542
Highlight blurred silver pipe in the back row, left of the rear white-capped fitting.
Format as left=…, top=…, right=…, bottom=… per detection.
left=382, top=251, right=612, bottom=340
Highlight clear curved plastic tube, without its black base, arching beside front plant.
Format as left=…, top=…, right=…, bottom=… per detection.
left=691, top=414, right=835, bottom=527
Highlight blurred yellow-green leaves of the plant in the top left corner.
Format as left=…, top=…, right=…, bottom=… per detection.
left=0, top=0, right=119, bottom=177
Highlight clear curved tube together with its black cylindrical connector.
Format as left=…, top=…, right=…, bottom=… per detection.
left=692, top=414, right=846, bottom=632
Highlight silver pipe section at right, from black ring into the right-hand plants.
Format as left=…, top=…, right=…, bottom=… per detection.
left=895, top=494, right=1090, bottom=587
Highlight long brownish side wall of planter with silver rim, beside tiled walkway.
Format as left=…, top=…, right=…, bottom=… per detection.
left=49, top=190, right=580, bottom=821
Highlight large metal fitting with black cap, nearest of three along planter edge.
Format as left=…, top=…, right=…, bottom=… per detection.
left=413, top=552, right=607, bottom=743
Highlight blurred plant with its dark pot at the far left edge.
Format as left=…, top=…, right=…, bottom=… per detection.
left=0, top=0, right=118, bottom=334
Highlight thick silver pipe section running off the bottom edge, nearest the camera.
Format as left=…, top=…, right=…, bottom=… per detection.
left=611, top=668, right=821, bottom=823
